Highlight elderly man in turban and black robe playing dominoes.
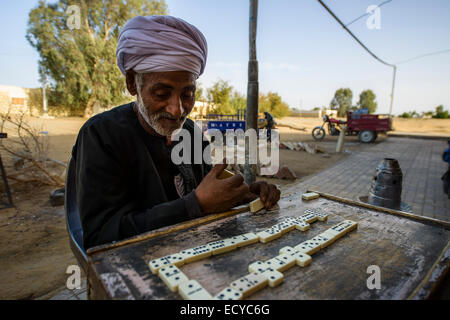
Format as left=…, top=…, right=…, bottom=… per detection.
left=72, top=16, right=280, bottom=249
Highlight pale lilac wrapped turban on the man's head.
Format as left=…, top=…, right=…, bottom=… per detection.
left=116, top=16, right=208, bottom=77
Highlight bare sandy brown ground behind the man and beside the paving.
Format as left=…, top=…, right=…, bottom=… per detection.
left=0, top=118, right=450, bottom=299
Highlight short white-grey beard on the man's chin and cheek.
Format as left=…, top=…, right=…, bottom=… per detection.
left=136, top=93, right=188, bottom=137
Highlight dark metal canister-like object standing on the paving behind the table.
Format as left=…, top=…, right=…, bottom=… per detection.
left=368, top=158, right=403, bottom=210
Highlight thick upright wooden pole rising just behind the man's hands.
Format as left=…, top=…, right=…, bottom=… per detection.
left=244, top=0, right=259, bottom=185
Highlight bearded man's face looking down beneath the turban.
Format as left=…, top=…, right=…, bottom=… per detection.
left=137, top=71, right=196, bottom=136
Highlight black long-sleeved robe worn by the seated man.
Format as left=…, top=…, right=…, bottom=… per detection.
left=72, top=103, right=211, bottom=249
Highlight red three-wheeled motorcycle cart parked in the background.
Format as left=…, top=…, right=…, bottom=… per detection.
left=312, top=112, right=392, bottom=143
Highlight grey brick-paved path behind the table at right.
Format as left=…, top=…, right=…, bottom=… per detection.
left=301, top=137, right=450, bottom=221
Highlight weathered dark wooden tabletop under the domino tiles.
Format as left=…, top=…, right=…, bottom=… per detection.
left=88, top=192, right=450, bottom=300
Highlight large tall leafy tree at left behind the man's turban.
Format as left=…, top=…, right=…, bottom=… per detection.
left=26, top=0, right=167, bottom=117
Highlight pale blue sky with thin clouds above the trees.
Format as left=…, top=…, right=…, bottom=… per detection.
left=0, top=0, right=450, bottom=114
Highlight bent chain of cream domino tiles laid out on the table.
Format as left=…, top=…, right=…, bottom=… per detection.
left=149, top=209, right=357, bottom=300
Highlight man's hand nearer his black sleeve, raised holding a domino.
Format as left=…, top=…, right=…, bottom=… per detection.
left=195, top=164, right=250, bottom=213
